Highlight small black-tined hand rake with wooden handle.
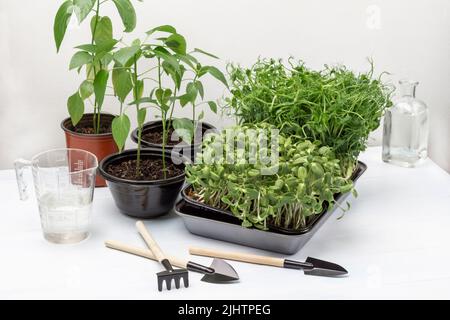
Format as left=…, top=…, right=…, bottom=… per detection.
left=136, top=221, right=189, bottom=291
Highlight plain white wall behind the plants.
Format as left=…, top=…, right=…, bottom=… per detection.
left=0, top=0, right=450, bottom=171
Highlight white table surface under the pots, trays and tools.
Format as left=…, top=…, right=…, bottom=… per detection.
left=0, top=148, right=450, bottom=299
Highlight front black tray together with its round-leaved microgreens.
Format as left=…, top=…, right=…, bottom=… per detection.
left=177, top=123, right=362, bottom=253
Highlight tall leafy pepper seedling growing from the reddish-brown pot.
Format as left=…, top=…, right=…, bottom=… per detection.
left=53, top=0, right=136, bottom=135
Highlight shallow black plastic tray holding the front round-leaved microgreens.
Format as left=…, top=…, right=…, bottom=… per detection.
left=175, top=162, right=367, bottom=255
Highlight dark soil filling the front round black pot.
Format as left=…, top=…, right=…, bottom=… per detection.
left=106, top=158, right=184, bottom=181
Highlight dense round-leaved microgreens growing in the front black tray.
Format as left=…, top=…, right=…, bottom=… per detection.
left=186, top=123, right=354, bottom=230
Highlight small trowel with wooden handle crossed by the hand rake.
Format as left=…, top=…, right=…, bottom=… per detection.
left=105, top=240, right=239, bottom=283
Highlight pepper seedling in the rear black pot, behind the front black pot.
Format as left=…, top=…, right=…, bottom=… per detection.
left=131, top=25, right=228, bottom=160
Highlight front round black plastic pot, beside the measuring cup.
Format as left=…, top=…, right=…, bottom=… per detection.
left=99, top=149, right=187, bottom=219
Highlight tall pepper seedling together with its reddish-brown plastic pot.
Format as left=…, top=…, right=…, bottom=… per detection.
left=54, top=0, right=136, bottom=186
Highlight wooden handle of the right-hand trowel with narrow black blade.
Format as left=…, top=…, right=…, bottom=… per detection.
left=189, top=247, right=284, bottom=268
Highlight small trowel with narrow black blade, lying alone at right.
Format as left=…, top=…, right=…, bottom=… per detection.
left=189, top=248, right=347, bottom=277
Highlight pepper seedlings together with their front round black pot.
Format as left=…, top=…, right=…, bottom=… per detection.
left=99, top=25, right=221, bottom=218
